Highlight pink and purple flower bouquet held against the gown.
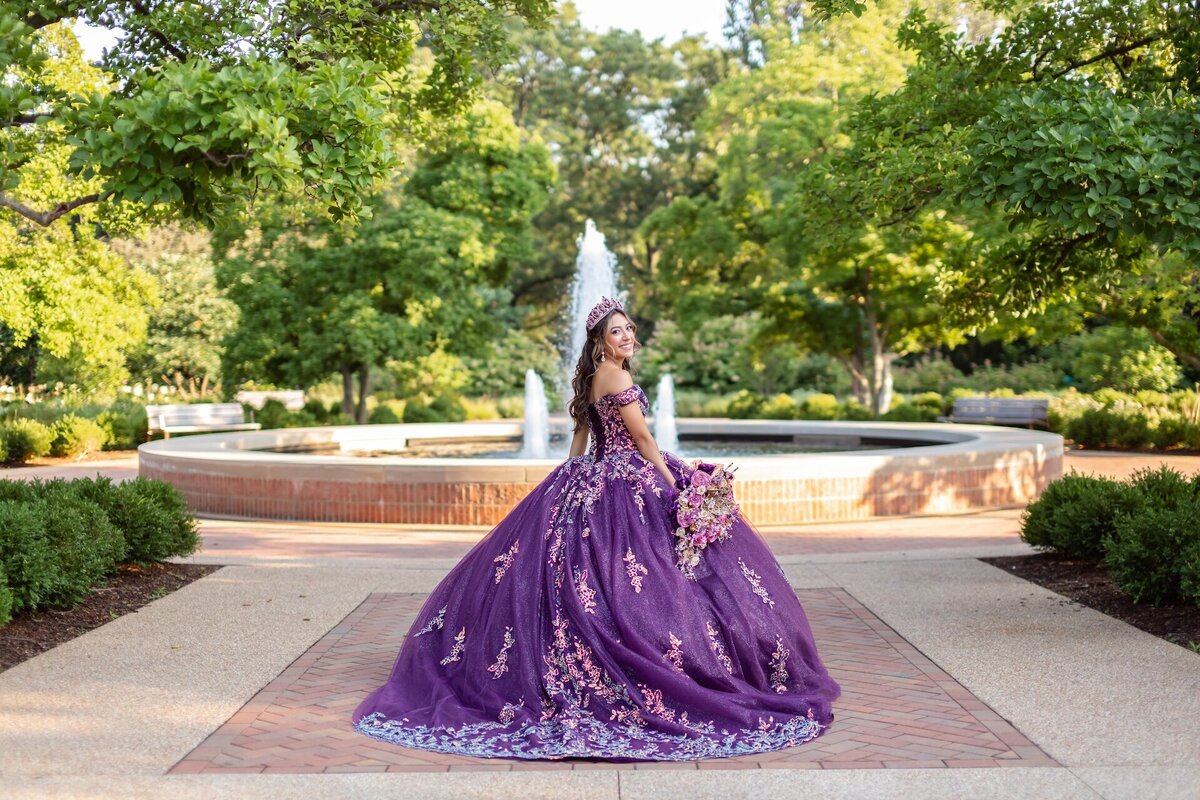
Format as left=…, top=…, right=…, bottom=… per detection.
left=673, top=462, right=738, bottom=578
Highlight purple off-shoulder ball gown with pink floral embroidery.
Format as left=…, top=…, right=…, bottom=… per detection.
left=354, top=386, right=840, bottom=760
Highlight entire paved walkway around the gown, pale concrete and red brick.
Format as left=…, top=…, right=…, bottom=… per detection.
left=0, top=451, right=1200, bottom=800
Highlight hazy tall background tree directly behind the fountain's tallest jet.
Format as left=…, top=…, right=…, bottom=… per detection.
left=496, top=2, right=726, bottom=325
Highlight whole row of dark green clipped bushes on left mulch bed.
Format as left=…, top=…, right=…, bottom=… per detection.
left=0, top=477, right=199, bottom=625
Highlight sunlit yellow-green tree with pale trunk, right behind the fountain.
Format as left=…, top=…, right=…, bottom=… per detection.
left=643, top=1, right=967, bottom=411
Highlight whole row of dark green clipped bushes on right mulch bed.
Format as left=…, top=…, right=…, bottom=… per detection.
left=1021, top=465, right=1200, bottom=606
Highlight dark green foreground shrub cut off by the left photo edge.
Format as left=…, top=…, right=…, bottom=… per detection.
left=0, top=500, right=59, bottom=612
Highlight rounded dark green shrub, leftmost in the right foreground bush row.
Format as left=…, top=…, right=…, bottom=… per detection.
left=1021, top=473, right=1139, bottom=559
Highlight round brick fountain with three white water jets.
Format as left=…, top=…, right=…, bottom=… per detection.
left=138, top=221, right=1062, bottom=525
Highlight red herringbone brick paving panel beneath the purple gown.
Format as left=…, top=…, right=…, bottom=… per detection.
left=170, top=589, right=1056, bottom=774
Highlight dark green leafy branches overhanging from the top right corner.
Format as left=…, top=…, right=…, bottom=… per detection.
left=808, top=0, right=1200, bottom=311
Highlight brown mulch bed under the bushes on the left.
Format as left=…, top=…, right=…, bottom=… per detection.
left=0, top=564, right=221, bottom=672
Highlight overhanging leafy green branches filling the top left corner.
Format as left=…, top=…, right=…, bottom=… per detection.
left=0, top=0, right=550, bottom=231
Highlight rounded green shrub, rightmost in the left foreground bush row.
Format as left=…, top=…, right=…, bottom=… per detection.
left=106, top=477, right=200, bottom=564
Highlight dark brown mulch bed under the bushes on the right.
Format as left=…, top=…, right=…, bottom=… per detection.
left=980, top=553, right=1200, bottom=648
